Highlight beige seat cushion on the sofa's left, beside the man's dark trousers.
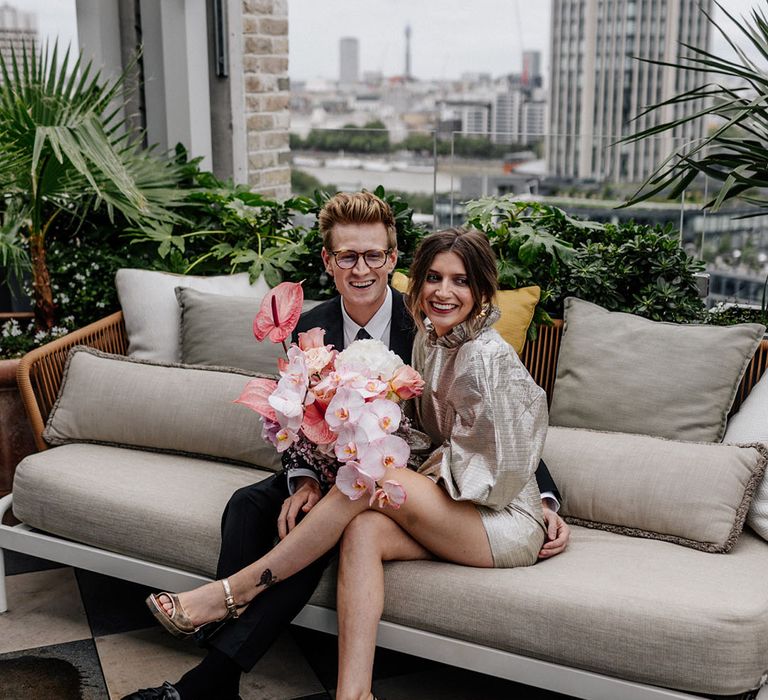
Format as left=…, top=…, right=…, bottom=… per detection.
left=13, top=444, right=271, bottom=576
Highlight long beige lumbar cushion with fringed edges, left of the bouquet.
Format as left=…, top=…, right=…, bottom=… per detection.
left=43, top=346, right=281, bottom=471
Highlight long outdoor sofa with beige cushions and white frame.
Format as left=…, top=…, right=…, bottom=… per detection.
left=0, top=274, right=768, bottom=699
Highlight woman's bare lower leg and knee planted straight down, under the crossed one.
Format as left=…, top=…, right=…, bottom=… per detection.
left=336, top=511, right=432, bottom=700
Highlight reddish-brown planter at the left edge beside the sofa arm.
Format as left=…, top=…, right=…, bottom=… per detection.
left=0, top=360, right=36, bottom=520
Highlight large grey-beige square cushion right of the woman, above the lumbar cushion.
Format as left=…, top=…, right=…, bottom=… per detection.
left=549, top=297, right=765, bottom=442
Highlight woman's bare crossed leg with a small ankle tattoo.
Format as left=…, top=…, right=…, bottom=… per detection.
left=159, top=469, right=493, bottom=625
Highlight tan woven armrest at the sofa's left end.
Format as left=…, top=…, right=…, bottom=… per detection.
left=16, top=311, right=128, bottom=450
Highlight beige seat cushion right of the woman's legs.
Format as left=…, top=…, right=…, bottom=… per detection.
left=310, top=527, right=768, bottom=698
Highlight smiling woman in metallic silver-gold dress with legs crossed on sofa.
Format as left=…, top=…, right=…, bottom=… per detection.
left=148, top=229, right=547, bottom=700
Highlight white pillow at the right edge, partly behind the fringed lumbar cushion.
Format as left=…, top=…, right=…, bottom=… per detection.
left=723, top=372, right=768, bottom=540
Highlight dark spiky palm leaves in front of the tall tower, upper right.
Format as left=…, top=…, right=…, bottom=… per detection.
left=622, top=0, right=768, bottom=216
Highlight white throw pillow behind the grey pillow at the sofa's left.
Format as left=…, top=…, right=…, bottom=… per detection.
left=115, top=269, right=269, bottom=362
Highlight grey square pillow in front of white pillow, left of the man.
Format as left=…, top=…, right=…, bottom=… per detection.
left=176, top=287, right=320, bottom=375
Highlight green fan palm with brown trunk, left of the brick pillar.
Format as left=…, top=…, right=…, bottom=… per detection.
left=0, top=44, right=188, bottom=329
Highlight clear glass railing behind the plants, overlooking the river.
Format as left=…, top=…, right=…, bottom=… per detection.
left=292, top=128, right=768, bottom=306
